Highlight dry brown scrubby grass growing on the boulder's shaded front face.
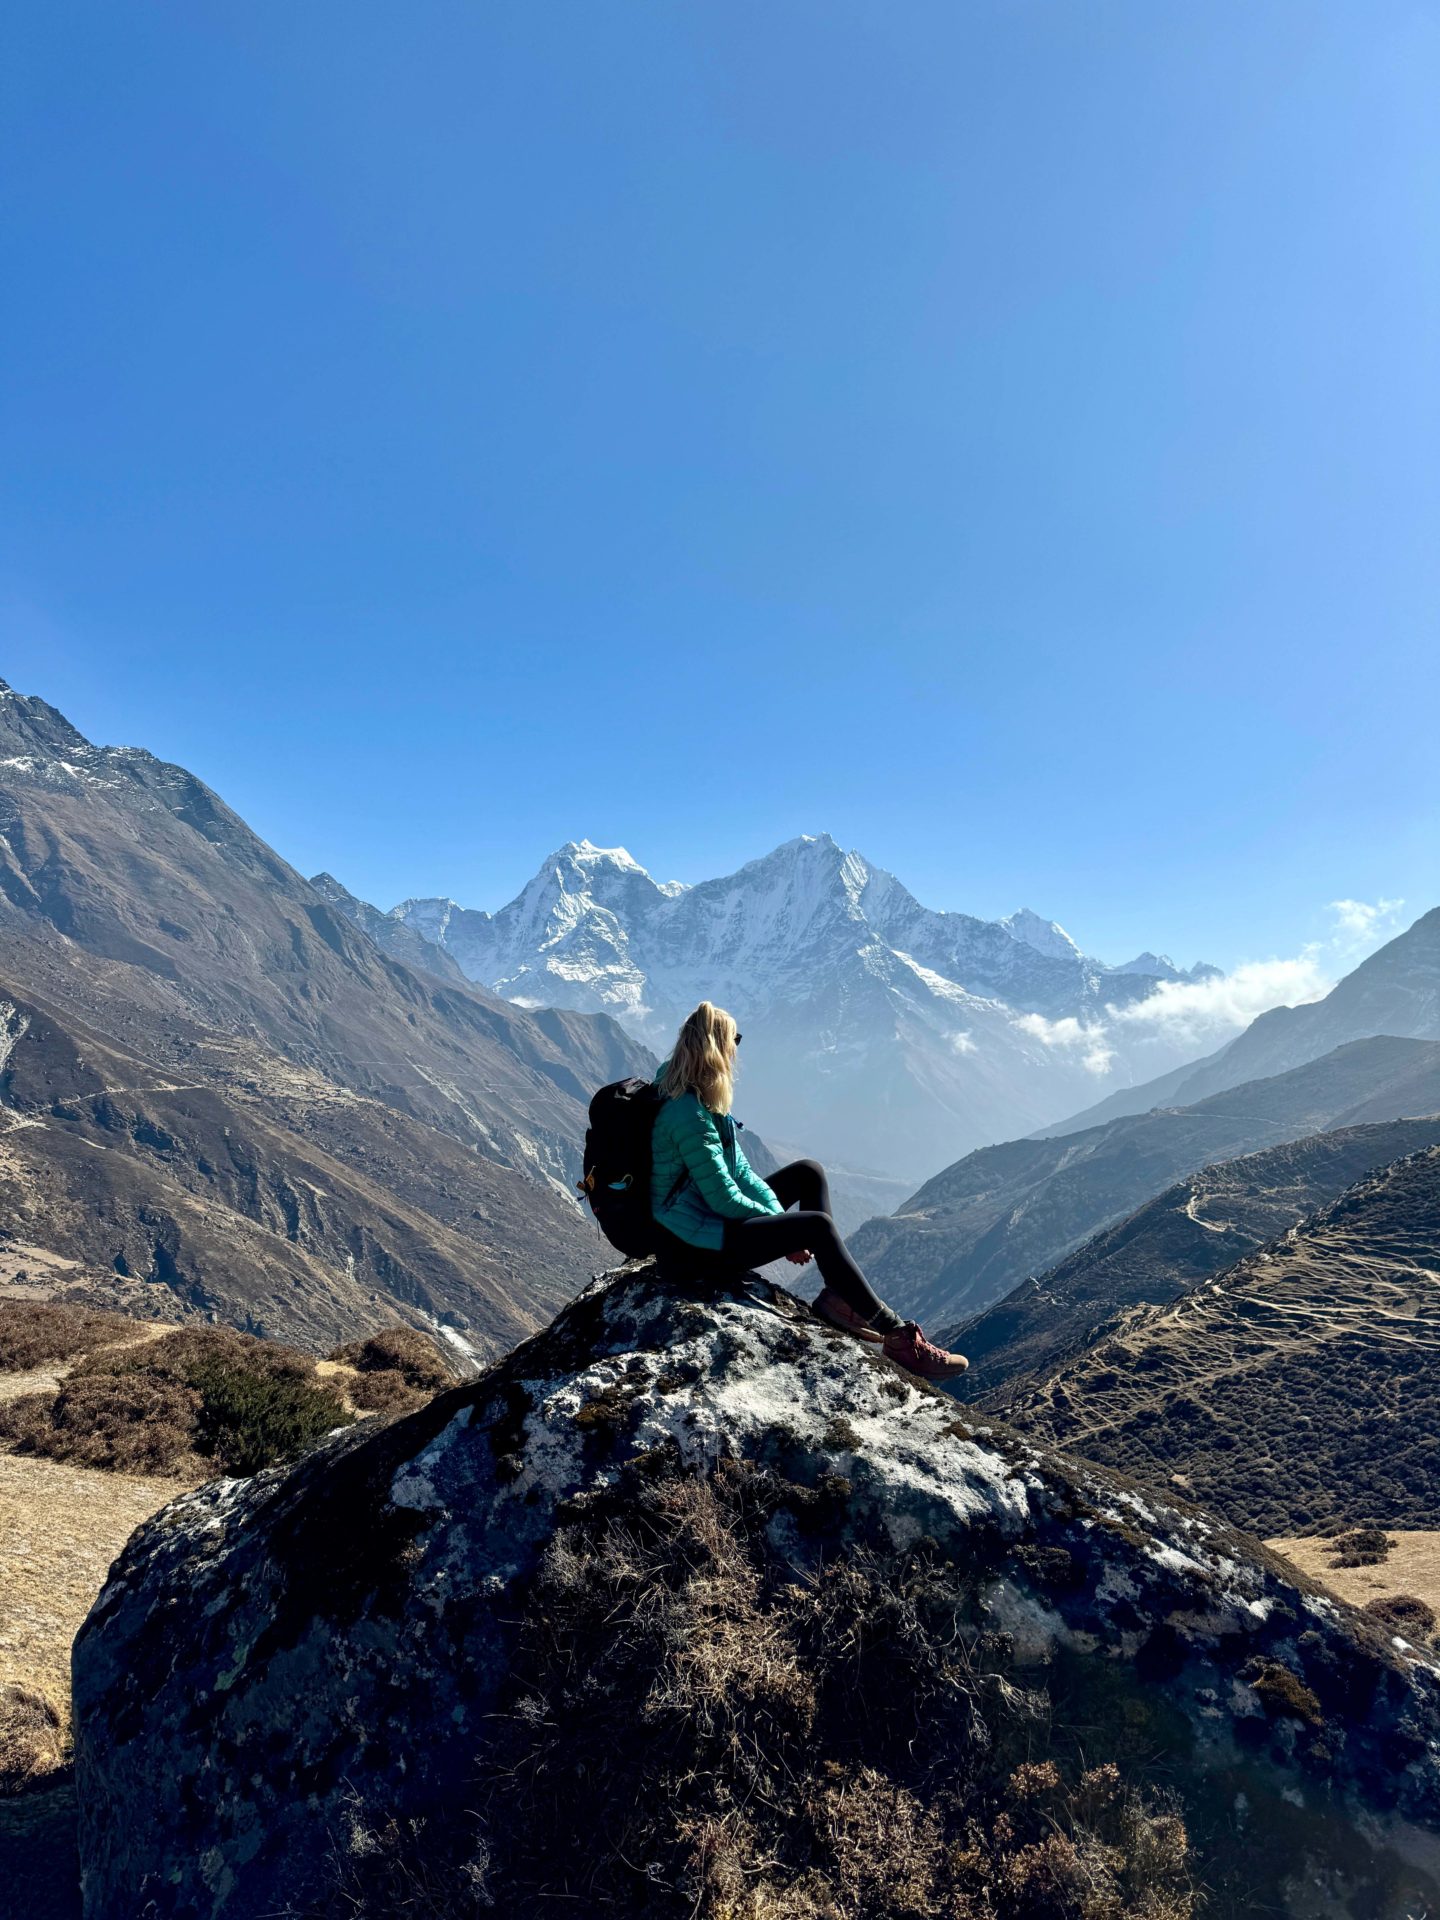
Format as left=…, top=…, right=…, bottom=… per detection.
left=317, top=1467, right=1194, bottom=1920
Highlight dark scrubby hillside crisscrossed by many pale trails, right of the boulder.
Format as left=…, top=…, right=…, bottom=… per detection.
left=987, top=1146, right=1440, bottom=1534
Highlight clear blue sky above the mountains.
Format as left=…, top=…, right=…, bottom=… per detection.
left=0, top=0, right=1440, bottom=964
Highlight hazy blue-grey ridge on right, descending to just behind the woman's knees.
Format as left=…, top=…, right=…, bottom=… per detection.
left=852, top=1039, right=1440, bottom=1327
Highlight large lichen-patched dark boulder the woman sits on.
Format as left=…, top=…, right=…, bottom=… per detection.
left=75, top=1269, right=1440, bottom=1920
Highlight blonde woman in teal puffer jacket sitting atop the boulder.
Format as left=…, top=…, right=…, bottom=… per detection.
left=651, top=1000, right=968, bottom=1380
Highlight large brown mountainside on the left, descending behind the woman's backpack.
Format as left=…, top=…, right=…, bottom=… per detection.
left=0, top=685, right=653, bottom=1357
